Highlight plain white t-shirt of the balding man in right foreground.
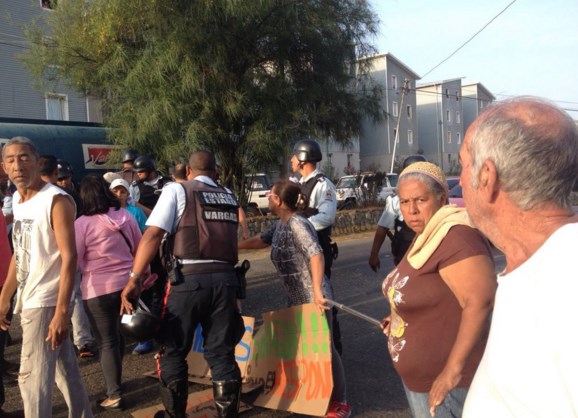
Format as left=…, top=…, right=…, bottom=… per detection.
left=463, top=223, right=578, bottom=418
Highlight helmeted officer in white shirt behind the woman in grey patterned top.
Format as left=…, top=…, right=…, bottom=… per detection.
left=291, top=139, right=342, bottom=354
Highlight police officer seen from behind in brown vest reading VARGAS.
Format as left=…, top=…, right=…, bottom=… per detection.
left=122, top=151, right=244, bottom=418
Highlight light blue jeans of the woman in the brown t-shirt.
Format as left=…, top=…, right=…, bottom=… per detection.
left=403, top=385, right=468, bottom=418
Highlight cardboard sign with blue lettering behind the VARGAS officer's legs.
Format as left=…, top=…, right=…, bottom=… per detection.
left=187, top=316, right=255, bottom=385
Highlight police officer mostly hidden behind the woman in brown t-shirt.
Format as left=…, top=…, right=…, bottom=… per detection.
left=369, top=155, right=426, bottom=272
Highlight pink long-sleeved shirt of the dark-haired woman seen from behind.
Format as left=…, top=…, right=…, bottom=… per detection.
left=74, top=208, right=141, bottom=300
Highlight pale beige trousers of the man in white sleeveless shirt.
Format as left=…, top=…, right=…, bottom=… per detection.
left=18, top=307, right=93, bottom=418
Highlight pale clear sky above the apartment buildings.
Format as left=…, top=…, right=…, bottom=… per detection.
left=370, top=0, right=578, bottom=120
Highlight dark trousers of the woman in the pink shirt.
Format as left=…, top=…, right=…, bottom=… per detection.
left=84, top=291, right=124, bottom=399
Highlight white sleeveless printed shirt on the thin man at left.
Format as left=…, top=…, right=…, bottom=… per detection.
left=12, top=184, right=72, bottom=313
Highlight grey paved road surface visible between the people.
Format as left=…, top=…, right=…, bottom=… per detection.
left=0, top=233, right=502, bottom=418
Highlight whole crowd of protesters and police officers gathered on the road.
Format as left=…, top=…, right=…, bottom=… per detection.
left=0, top=97, right=578, bottom=418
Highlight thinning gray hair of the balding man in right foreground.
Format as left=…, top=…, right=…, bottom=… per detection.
left=467, top=96, right=578, bottom=210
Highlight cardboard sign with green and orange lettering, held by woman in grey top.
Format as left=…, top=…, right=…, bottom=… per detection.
left=245, top=304, right=333, bottom=416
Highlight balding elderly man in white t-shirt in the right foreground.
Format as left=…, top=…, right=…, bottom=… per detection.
left=460, top=97, right=578, bottom=418
